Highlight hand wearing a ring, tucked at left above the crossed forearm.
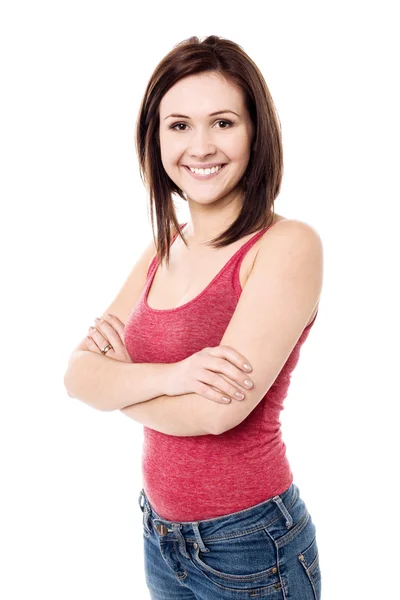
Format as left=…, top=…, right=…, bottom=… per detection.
left=86, top=315, right=132, bottom=362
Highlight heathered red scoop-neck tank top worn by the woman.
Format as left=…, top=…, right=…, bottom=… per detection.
left=125, top=223, right=316, bottom=522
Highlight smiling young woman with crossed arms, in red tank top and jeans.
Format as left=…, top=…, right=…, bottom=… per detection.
left=65, top=36, right=323, bottom=600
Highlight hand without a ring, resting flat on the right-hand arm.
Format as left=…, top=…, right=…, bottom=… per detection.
left=166, top=346, right=253, bottom=404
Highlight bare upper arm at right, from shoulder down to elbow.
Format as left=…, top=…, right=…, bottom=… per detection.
left=208, top=220, right=323, bottom=434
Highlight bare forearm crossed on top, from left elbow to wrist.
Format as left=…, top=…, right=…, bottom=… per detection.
left=64, top=350, right=170, bottom=411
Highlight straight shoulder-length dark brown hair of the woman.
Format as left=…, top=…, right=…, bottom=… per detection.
left=136, top=35, right=283, bottom=265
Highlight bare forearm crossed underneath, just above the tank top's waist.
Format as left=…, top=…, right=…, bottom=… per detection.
left=121, top=394, right=219, bottom=436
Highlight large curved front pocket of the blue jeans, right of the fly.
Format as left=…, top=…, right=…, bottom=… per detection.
left=189, top=529, right=281, bottom=598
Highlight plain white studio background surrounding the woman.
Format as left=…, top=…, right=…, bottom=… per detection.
left=0, top=0, right=400, bottom=600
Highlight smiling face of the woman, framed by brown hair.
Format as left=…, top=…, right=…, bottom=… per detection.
left=159, top=73, right=253, bottom=204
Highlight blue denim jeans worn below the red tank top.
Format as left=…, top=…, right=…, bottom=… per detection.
left=139, top=483, right=321, bottom=600
